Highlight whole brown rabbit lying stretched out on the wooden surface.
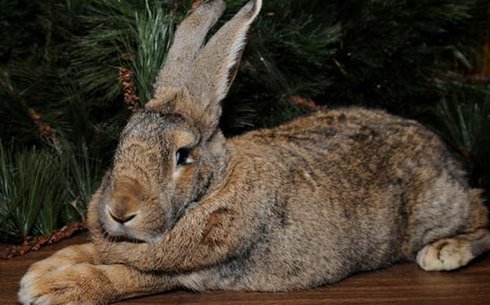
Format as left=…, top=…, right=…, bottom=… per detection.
left=18, top=0, right=490, bottom=304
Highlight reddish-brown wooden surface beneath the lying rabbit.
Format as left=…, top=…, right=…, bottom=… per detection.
left=0, top=235, right=490, bottom=305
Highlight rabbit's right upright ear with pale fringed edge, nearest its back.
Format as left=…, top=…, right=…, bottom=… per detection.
left=186, top=0, right=262, bottom=126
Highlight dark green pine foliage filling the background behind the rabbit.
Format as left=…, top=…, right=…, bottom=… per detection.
left=0, top=0, right=490, bottom=240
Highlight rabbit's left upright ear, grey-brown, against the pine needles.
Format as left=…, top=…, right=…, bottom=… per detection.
left=155, top=0, right=226, bottom=93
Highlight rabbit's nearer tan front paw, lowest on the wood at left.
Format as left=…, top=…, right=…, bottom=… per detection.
left=18, top=263, right=115, bottom=305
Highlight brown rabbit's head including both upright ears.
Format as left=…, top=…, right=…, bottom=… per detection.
left=89, top=0, right=262, bottom=241
